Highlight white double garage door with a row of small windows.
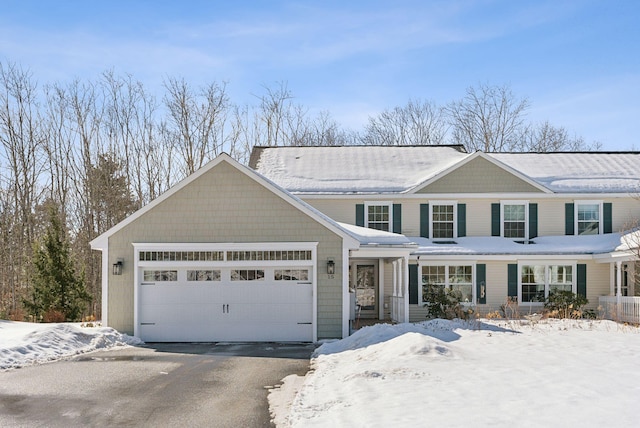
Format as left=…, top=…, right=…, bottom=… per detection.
left=137, top=246, right=314, bottom=342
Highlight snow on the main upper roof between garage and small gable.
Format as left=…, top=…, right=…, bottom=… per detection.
left=252, top=146, right=469, bottom=194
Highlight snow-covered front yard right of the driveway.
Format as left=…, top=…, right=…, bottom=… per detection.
left=269, top=320, right=640, bottom=427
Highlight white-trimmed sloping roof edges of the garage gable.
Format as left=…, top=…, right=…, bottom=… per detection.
left=90, top=153, right=360, bottom=250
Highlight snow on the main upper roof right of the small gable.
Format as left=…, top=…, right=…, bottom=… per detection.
left=487, top=152, right=640, bottom=193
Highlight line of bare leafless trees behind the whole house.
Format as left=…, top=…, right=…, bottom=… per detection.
left=0, top=62, right=599, bottom=319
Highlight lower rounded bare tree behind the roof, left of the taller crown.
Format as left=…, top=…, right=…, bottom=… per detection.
left=362, top=100, right=447, bottom=146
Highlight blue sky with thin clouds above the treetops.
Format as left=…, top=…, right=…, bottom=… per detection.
left=0, top=0, right=640, bottom=150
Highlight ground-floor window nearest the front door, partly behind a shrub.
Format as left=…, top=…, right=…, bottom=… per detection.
left=420, top=264, right=474, bottom=304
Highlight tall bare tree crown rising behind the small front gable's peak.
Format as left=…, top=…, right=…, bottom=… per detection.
left=446, top=85, right=529, bottom=152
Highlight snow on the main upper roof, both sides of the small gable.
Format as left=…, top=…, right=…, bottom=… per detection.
left=252, top=146, right=640, bottom=194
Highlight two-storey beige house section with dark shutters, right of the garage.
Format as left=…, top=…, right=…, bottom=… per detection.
left=250, top=146, right=640, bottom=321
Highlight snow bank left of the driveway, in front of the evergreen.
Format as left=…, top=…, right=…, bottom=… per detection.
left=0, top=320, right=142, bottom=370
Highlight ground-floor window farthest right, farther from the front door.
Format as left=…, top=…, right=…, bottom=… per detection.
left=519, top=263, right=576, bottom=304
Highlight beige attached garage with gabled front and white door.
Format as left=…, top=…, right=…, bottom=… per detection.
left=91, top=154, right=360, bottom=342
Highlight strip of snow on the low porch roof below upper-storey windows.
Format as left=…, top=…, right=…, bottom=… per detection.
left=411, top=233, right=621, bottom=256
